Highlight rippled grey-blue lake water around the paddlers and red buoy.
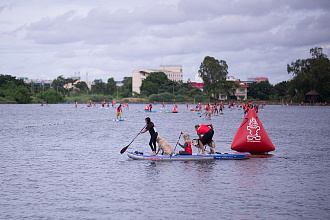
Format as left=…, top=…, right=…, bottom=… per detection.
left=0, top=104, right=330, bottom=220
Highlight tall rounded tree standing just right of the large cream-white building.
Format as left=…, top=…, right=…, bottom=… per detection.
left=198, top=56, right=228, bottom=99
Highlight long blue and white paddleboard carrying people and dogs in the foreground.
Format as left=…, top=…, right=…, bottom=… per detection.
left=127, top=151, right=251, bottom=161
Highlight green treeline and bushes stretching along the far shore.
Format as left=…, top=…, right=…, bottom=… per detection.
left=0, top=47, right=330, bottom=104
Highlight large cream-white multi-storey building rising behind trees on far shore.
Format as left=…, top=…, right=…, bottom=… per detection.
left=132, top=65, right=183, bottom=94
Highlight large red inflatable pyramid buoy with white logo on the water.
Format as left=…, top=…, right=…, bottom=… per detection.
left=231, top=109, right=275, bottom=154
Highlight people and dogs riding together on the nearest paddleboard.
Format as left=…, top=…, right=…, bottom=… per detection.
left=139, top=117, right=214, bottom=155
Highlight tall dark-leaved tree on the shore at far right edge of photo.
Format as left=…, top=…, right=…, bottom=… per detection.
left=287, top=47, right=330, bottom=101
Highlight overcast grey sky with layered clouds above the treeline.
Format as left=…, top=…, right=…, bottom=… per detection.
left=0, top=0, right=330, bottom=85
